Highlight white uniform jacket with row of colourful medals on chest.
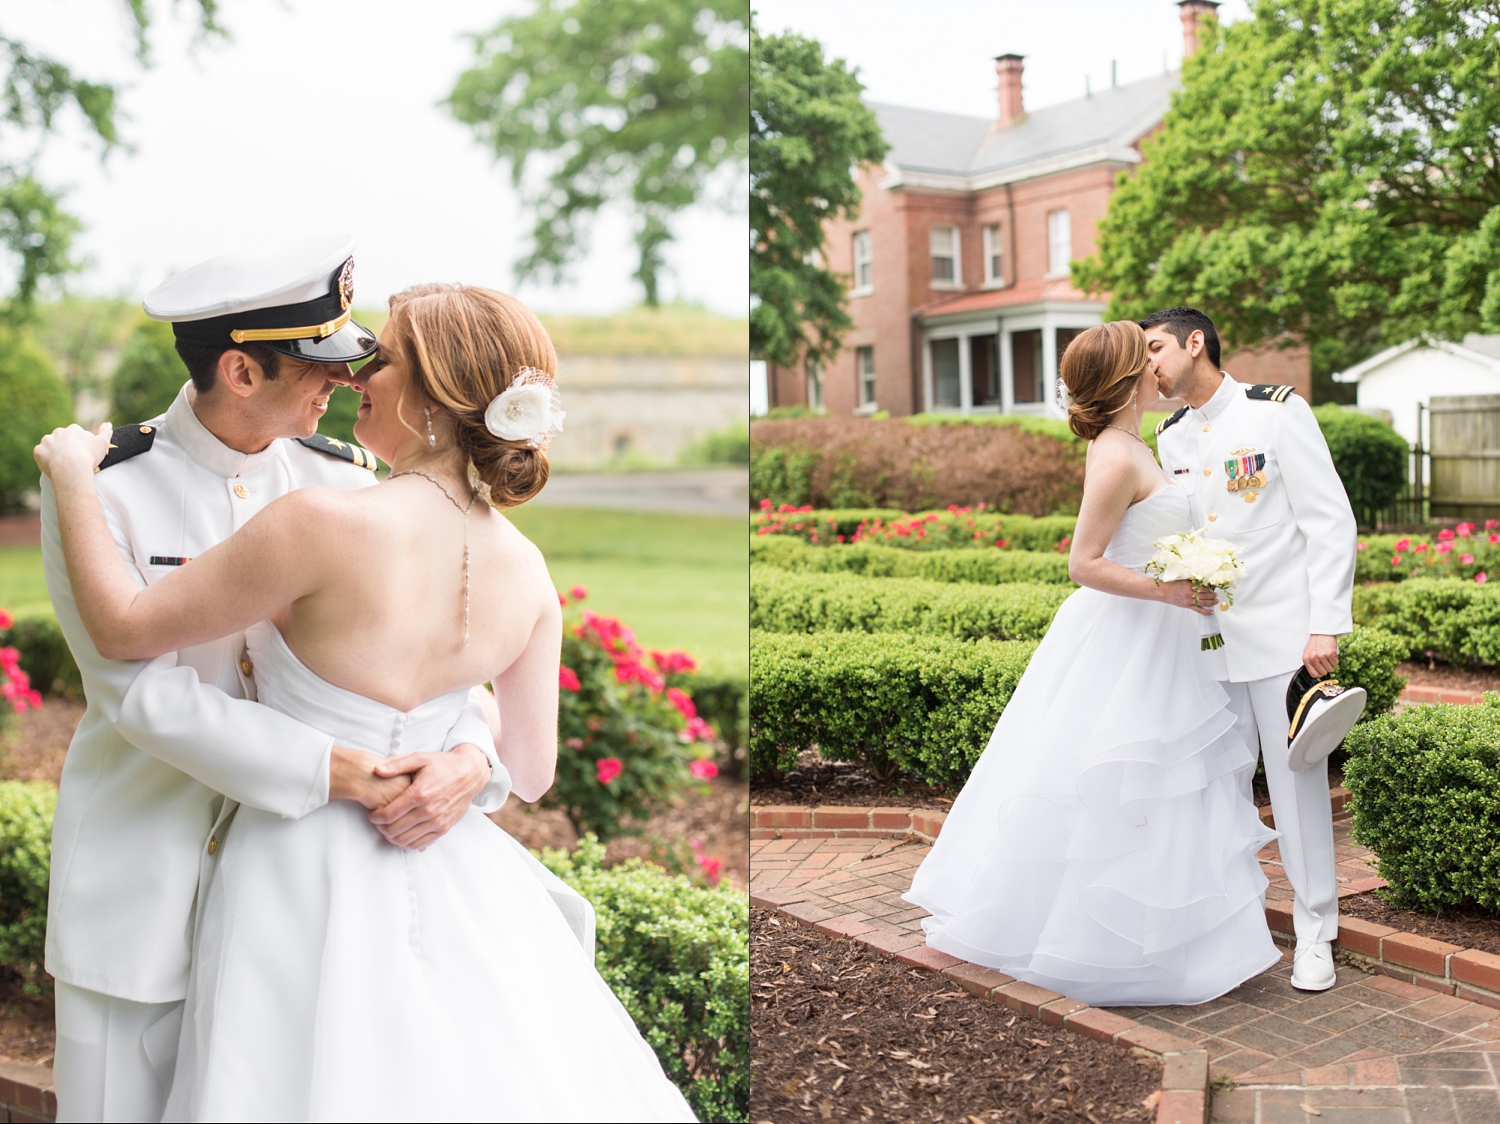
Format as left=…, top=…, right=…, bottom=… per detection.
left=1157, top=375, right=1356, bottom=683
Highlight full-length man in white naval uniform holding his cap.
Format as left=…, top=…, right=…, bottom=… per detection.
left=1140, top=308, right=1356, bottom=990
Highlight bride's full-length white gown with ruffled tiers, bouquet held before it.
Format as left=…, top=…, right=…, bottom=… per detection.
left=906, top=485, right=1281, bottom=1005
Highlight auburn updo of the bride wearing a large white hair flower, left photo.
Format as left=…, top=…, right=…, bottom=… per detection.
left=390, top=285, right=558, bottom=507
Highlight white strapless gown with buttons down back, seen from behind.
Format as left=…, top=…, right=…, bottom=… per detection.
left=167, top=624, right=693, bottom=1121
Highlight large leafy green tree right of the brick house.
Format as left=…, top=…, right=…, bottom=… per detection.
left=1074, top=0, right=1500, bottom=398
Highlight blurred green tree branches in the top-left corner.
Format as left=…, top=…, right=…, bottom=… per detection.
left=0, top=7, right=224, bottom=324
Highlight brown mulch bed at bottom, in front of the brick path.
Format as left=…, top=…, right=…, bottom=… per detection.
left=750, top=909, right=1161, bottom=1124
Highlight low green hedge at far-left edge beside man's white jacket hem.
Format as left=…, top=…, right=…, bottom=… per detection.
left=0, top=780, right=57, bottom=993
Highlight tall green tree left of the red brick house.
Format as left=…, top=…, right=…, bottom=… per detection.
left=750, top=27, right=890, bottom=366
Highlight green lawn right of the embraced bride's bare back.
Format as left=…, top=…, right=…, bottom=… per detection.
left=510, top=507, right=750, bottom=674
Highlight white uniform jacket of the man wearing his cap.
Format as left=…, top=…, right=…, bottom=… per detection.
left=42, top=387, right=509, bottom=1002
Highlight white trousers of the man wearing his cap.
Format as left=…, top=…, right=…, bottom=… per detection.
left=53, top=980, right=183, bottom=1124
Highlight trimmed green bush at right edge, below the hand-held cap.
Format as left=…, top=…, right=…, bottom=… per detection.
left=1344, top=695, right=1500, bottom=914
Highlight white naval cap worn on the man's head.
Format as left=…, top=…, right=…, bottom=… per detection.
left=144, top=234, right=375, bottom=363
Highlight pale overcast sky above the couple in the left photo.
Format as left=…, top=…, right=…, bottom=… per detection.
left=0, top=0, right=749, bottom=315
